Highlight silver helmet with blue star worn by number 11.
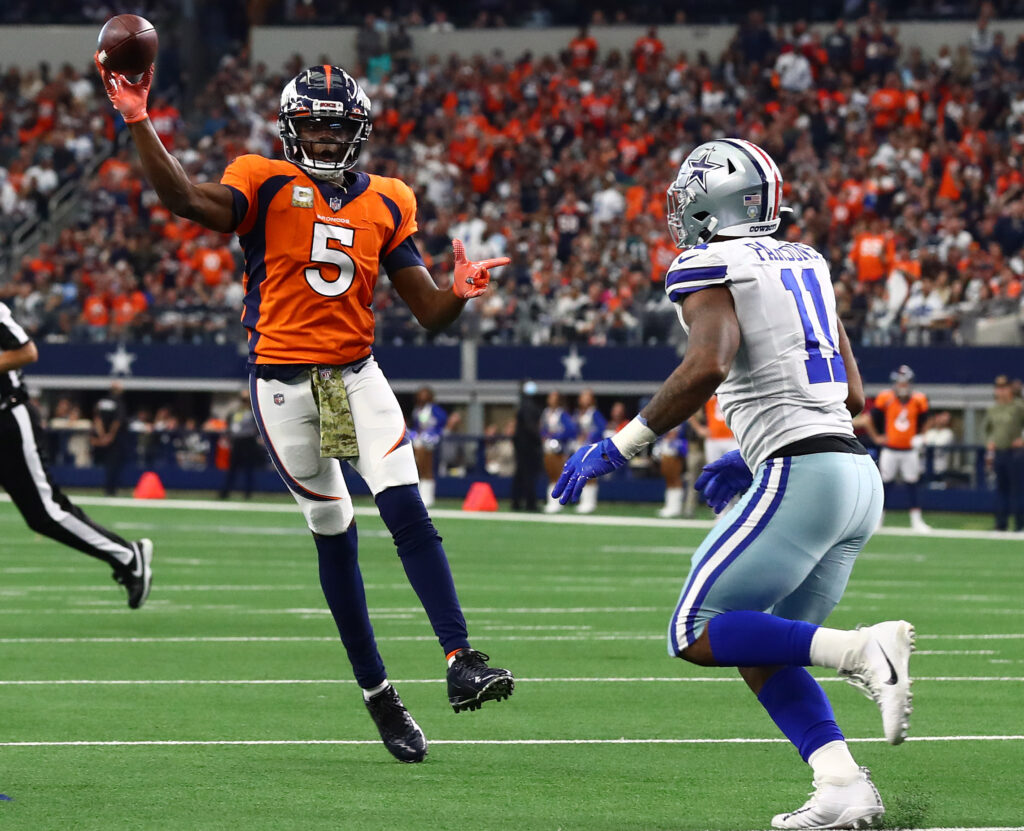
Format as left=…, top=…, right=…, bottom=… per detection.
left=668, top=138, right=782, bottom=248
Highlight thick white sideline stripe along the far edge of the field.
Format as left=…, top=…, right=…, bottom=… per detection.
left=0, top=494, right=1024, bottom=544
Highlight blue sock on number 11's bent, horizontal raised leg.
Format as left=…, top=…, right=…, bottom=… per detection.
left=708, top=611, right=818, bottom=666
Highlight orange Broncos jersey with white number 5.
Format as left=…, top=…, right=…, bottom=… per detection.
left=220, top=156, right=423, bottom=364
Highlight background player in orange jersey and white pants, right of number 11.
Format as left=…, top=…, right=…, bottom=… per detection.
left=866, top=365, right=932, bottom=533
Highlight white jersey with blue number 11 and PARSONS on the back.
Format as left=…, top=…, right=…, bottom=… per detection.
left=665, top=236, right=853, bottom=470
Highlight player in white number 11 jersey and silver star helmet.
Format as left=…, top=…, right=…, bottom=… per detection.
left=554, top=138, right=913, bottom=828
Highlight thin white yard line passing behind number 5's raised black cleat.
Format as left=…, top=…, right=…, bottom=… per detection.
left=0, top=675, right=1024, bottom=687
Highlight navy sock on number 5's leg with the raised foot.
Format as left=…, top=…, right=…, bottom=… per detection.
left=375, top=485, right=469, bottom=654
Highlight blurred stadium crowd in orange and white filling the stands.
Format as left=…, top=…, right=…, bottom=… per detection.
left=0, top=10, right=1024, bottom=345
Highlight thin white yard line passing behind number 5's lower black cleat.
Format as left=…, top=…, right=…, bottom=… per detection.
left=0, top=736, right=1024, bottom=749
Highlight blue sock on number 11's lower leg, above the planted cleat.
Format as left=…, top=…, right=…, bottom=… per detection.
left=758, top=666, right=845, bottom=761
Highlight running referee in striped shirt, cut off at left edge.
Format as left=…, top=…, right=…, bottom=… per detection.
left=0, top=303, right=153, bottom=609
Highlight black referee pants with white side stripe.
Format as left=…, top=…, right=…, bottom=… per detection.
left=0, top=403, right=134, bottom=566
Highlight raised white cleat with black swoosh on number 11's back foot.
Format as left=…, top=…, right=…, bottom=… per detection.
left=839, top=620, right=914, bottom=744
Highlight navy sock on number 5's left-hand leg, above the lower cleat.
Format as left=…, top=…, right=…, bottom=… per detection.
left=313, top=522, right=387, bottom=690
